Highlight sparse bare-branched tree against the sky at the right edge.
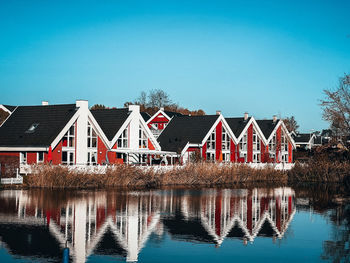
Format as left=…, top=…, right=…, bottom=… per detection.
left=321, top=74, right=350, bottom=137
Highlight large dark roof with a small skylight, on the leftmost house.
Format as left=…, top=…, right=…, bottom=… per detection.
left=0, top=104, right=77, bottom=147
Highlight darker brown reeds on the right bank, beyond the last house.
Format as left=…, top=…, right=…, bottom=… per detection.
left=288, top=158, right=350, bottom=183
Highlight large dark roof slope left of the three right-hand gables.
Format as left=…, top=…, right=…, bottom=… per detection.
left=158, top=115, right=219, bottom=153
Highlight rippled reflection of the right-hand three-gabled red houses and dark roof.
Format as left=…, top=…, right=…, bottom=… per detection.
left=163, top=188, right=295, bottom=245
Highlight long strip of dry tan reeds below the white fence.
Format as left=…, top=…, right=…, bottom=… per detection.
left=24, top=163, right=287, bottom=188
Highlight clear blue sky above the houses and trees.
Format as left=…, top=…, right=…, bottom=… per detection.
left=0, top=0, right=350, bottom=132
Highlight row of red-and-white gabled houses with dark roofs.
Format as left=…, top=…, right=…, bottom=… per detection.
left=0, top=100, right=295, bottom=176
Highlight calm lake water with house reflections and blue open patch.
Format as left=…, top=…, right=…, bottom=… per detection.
left=0, top=185, right=350, bottom=262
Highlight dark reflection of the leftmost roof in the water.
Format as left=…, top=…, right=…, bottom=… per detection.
left=0, top=224, right=62, bottom=262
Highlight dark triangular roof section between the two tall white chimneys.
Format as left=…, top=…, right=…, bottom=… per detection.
left=91, top=108, right=129, bottom=141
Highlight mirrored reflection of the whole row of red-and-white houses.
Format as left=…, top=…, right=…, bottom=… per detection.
left=0, top=187, right=296, bottom=262
